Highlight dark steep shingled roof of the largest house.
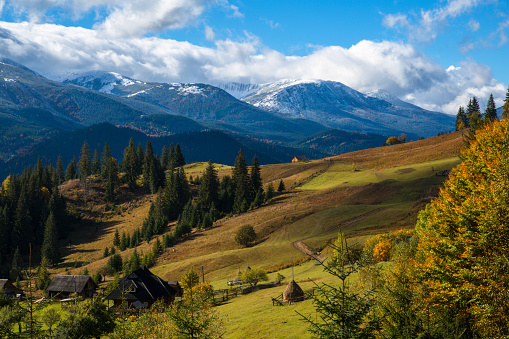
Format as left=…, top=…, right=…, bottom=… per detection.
left=106, top=265, right=177, bottom=301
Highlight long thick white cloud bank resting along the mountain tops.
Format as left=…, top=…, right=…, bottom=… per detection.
left=0, top=22, right=506, bottom=113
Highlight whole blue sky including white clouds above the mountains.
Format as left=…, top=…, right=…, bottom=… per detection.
left=0, top=0, right=509, bottom=114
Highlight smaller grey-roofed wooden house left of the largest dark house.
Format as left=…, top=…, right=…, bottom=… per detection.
left=46, top=275, right=97, bottom=299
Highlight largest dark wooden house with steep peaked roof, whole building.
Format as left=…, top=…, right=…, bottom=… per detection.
left=106, top=265, right=178, bottom=308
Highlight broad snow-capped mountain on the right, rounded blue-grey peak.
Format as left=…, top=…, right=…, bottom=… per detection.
left=218, top=80, right=454, bottom=137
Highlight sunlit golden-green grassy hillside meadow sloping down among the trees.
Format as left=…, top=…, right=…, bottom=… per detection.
left=55, top=133, right=463, bottom=338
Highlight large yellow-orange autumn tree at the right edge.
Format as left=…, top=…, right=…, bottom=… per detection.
left=416, top=119, right=509, bottom=338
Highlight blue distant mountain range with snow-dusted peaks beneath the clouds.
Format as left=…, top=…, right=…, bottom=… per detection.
left=0, top=60, right=454, bottom=174
